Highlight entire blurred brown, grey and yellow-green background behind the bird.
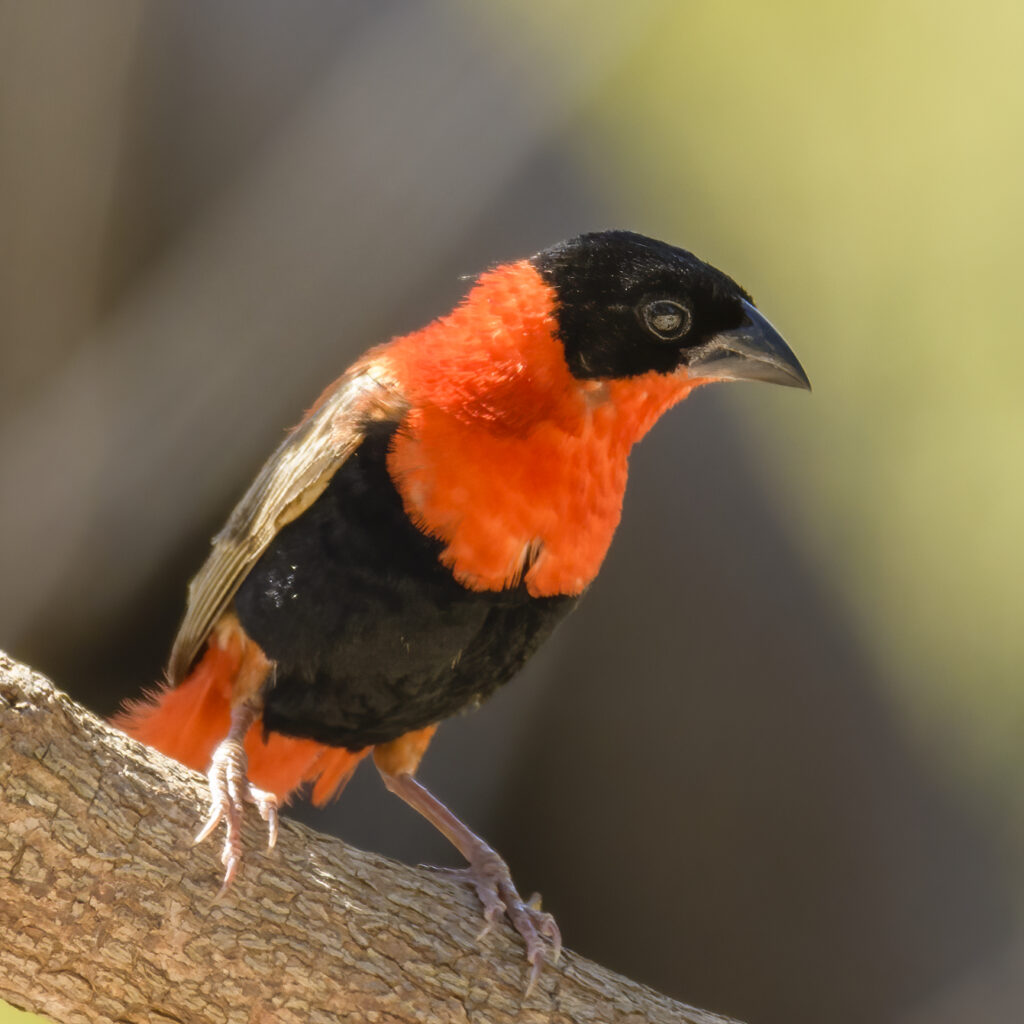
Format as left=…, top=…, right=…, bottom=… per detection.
left=0, top=0, right=1024, bottom=1024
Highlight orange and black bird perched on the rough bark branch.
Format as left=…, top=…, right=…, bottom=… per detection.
left=115, top=230, right=810, bottom=991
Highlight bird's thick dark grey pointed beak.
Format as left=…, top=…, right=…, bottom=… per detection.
left=686, top=301, right=811, bottom=391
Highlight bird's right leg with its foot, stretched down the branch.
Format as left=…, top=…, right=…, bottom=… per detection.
left=375, top=754, right=562, bottom=995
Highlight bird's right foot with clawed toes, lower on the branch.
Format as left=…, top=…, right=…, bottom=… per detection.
left=434, top=845, right=562, bottom=995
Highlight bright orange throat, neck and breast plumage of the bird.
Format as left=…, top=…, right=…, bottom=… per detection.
left=386, top=263, right=692, bottom=597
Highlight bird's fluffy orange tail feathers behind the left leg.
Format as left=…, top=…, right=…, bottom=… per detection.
left=113, top=643, right=371, bottom=804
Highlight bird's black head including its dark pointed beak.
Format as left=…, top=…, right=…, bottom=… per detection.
left=531, top=231, right=809, bottom=387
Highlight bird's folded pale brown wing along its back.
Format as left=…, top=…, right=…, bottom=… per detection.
left=167, top=362, right=406, bottom=685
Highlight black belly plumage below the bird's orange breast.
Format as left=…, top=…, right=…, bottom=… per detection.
left=234, top=419, right=578, bottom=750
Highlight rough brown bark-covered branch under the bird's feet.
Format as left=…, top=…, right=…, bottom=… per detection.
left=0, top=653, right=729, bottom=1024
